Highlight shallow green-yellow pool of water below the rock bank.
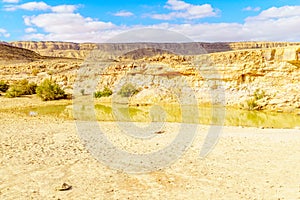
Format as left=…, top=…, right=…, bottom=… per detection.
left=20, top=104, right=300, bottom=128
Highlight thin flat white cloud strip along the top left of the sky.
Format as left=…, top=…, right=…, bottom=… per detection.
left=4, top=1, right=78, bottom=13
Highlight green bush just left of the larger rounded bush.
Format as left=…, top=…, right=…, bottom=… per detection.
left=6, top=79, right=37, bottom=98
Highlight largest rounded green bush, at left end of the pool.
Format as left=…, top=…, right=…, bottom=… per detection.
left=36, top=79, right=66, bottom=101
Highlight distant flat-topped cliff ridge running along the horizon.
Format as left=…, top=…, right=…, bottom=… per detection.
left=10, top=41, right=300, bottom=59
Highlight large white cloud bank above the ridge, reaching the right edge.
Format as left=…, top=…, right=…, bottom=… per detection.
left=166, top=6, right=300, bottom=42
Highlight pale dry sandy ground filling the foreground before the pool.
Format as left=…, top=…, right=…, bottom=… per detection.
left=0, top=98, right=300, bottom=199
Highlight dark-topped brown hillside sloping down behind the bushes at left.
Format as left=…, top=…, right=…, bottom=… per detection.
left=0, top=43, right=82, bottom=85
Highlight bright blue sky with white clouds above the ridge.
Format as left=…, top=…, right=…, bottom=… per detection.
left=0, top=0, right=300, bottom=42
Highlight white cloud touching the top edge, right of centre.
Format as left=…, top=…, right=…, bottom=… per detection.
left=151, top=0, right=217, bottom=20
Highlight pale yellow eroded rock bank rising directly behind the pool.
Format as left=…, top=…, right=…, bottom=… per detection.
left=73, top=46, right=300, bottom=112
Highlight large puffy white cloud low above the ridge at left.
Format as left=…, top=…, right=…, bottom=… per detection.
left=24, top=13, right=117, bottom=41
